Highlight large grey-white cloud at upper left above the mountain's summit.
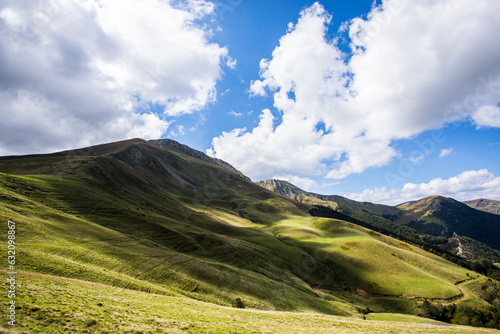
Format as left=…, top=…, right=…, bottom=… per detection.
left=0, top=0, right=227, bottom=154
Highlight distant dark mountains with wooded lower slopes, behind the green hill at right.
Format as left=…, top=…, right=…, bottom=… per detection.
left=257, top=180, right=500, bottom=261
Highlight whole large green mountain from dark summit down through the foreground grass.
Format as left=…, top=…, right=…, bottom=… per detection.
left=0, top=139, right=496, bottom=333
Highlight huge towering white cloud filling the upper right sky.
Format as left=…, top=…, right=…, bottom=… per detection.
left=210, top=0, right=500, bottom=179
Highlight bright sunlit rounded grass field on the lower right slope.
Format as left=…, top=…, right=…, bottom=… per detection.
left=272, top=218, right=467, bottom=298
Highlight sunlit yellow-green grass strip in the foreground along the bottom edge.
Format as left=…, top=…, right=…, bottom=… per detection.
left=0, top=271, right=498, bottom=334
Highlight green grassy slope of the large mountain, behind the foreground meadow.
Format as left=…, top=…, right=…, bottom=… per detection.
left=0, top=139, right=496, bottom=332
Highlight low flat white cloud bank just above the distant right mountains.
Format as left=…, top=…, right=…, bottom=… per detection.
left=344, top=169, right=500, bottom=205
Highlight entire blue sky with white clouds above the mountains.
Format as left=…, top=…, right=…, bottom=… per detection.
left=0, top=0, right=500, bottom=205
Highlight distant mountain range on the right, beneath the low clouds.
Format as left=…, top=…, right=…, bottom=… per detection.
left=257, top=180, right=500, bottom=257
